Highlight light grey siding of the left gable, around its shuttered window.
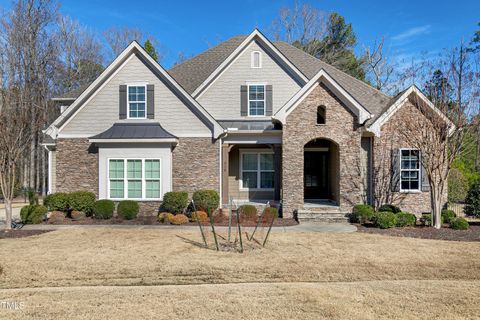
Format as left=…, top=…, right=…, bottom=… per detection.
left=60, top=55, right=211, bottom=137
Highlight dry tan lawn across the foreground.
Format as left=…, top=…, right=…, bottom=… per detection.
left=0, top=229, right=480, bottom=319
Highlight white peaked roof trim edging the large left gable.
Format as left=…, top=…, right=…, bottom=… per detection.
left=44, top=41, right=223, bottom=139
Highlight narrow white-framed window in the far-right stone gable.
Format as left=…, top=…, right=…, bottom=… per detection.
left=400, top=149, right=420, bottom=191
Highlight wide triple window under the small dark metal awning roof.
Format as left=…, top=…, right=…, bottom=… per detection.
left=108, top=159, right=160, bottom=199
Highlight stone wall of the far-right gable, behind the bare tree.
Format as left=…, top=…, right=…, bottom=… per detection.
left=373, top=102, right=447, bottom=216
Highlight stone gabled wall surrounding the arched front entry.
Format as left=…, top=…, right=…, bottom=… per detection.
left=282, top=84, right=362, bottom=217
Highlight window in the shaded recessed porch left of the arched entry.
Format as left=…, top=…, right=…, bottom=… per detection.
left=241, top=152, right=275, bottom=190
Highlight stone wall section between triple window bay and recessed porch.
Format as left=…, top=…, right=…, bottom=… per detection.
left=172, top=138, right=220, bottom=195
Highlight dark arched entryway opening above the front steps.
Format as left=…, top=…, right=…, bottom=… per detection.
left=303, top=139, right=340, bottom=205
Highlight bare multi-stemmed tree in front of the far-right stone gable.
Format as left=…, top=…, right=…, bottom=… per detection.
left=400, top=44, right=480, bottom=228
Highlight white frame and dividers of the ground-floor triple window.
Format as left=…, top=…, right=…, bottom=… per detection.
left=107, top=157, right=163, bottom=201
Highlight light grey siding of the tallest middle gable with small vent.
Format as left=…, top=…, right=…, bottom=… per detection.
left=197, top=42, right=300, bottom=119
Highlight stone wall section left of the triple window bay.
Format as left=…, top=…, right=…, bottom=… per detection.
left=55, top=138, right=98, bottom=197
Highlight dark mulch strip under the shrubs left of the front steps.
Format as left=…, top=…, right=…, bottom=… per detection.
left=44, top=216, right=298, bottom=227
